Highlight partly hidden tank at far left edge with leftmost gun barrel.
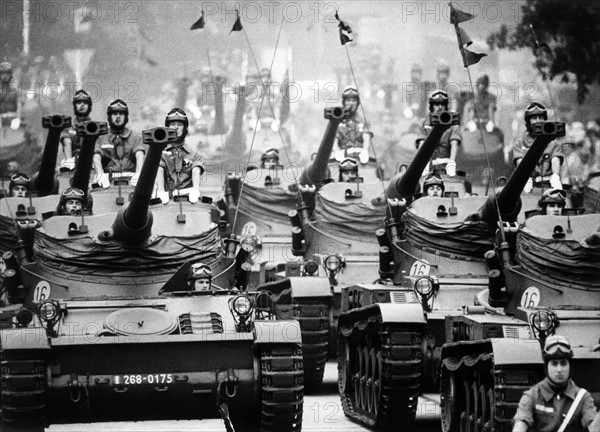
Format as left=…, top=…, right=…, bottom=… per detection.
left=0, top=114, right=71, bottom=255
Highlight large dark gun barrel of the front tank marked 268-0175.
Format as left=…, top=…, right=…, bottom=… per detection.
left=100, top=127, right=177, bottom=244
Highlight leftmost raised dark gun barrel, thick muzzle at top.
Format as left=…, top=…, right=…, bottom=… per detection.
left=33, top=114, right=71, bottom=196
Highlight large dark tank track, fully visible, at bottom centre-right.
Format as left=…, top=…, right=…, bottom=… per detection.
left=338, top=316, right=422, bottom=430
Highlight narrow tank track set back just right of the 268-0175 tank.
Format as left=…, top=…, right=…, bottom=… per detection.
left=294, top=298, right=330, bottom=391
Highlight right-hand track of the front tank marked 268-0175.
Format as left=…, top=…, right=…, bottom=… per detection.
left=260, top=344, right=304, bottom=432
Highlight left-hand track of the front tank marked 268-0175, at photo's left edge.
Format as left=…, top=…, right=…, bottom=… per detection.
left=0, top=353, right=47, bottom=425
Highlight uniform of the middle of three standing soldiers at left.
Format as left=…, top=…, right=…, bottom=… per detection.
left=94, top=127, right=146, bottom=171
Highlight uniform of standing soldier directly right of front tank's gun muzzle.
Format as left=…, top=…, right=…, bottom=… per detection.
left=160, top=142, right=204, bottom=190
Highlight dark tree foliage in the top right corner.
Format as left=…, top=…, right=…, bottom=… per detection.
left=487, top=0, right=600, bottom=103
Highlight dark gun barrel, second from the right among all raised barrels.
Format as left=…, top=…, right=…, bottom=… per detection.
left=385, top=111, right=458, bottom=200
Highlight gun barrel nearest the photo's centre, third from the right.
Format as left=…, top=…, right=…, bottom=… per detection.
left=300, top=107, right=349, bottom=186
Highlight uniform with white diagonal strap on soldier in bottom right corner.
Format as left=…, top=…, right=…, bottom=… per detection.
left=515, top=378, right=596, bottom=432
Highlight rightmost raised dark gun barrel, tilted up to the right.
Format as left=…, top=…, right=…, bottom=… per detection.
left=480, top=121, right=565, bottom=223
